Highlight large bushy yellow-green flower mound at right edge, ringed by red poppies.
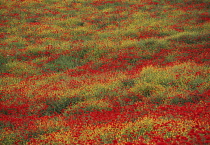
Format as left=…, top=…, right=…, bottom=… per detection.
left=130, top=63, right=209, bottom=105
